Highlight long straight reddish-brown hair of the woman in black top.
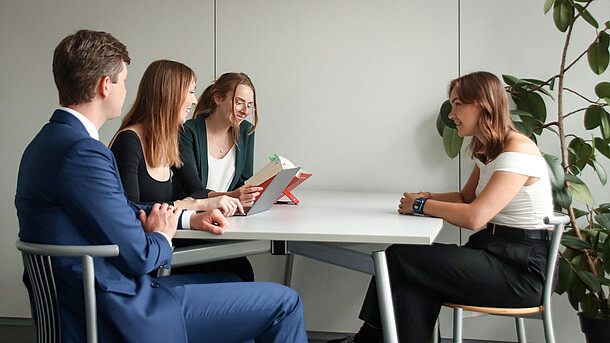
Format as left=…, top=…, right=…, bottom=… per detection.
left=110, top=60, right=196, bottom=168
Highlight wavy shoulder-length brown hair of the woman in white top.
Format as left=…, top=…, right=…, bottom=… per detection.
left=449, top=71, right=516, bottom=163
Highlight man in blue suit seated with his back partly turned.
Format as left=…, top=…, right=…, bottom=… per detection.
left=15, top=30, right=307, bottom=343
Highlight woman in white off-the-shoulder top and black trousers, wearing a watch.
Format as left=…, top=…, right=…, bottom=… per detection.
left=335, top=72, right=553, bottom=342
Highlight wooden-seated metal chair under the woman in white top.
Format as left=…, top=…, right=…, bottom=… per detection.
left=443, top=214, right=570, bottom=343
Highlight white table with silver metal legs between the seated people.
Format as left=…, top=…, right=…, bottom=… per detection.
left=172, top=190, right=443, bottom=343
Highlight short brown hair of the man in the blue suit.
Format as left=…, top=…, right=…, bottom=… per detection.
left=53, top=30, right=131, bottom=106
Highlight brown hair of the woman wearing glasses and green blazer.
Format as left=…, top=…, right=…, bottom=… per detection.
left=193, top=73, right=258, bottom=145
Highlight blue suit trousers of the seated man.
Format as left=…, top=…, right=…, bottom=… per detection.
left=153, top=273, right=307, bottom=343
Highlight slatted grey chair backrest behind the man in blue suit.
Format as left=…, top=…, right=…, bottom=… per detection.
left=15, top=240, right=119, bottom=343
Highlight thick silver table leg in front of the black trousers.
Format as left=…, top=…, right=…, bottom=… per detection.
left=373, top=250, right=398, bottom=343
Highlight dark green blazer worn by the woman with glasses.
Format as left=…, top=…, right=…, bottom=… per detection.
left=173, top=115, right=254, bottom=199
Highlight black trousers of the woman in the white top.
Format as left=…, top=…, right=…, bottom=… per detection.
left=360, top=229, right=549, bottom=343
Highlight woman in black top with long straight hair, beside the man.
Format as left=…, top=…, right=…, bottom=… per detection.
left=110, top=60, right=241, bottom=220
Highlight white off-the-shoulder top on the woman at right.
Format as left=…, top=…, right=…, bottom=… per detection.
left=475, top=152, right=553, bottom=229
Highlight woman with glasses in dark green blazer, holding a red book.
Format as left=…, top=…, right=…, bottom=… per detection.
left=174, top=73, right=262, bottom=281
